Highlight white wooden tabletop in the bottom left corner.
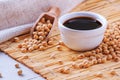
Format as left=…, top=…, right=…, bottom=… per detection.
left=0, top=52, right=45, bottom=80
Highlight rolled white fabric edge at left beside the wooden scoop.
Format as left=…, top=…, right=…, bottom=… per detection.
left=0, top=23, right=33, bottom=43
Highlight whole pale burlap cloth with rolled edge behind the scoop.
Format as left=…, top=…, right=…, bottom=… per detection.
left=0, top=0, right=83, bottom=43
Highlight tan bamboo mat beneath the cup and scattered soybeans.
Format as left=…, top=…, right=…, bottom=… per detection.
left=0, top=0, right=120, bottom=80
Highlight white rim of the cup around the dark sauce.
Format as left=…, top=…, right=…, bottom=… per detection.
left=58, top=11, right=108, bottom=32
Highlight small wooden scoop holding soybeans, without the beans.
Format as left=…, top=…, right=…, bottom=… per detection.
left=31, top=6, right=60, bottom=40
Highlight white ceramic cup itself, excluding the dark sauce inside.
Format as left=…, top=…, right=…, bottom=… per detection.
left=58, top=11, right=107, bottom=51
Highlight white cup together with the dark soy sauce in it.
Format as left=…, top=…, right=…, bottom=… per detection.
left=58, top=11, right=107, bottom=51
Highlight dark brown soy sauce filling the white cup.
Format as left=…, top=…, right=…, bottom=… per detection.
left=63, top=17, right=102, bottom=30
